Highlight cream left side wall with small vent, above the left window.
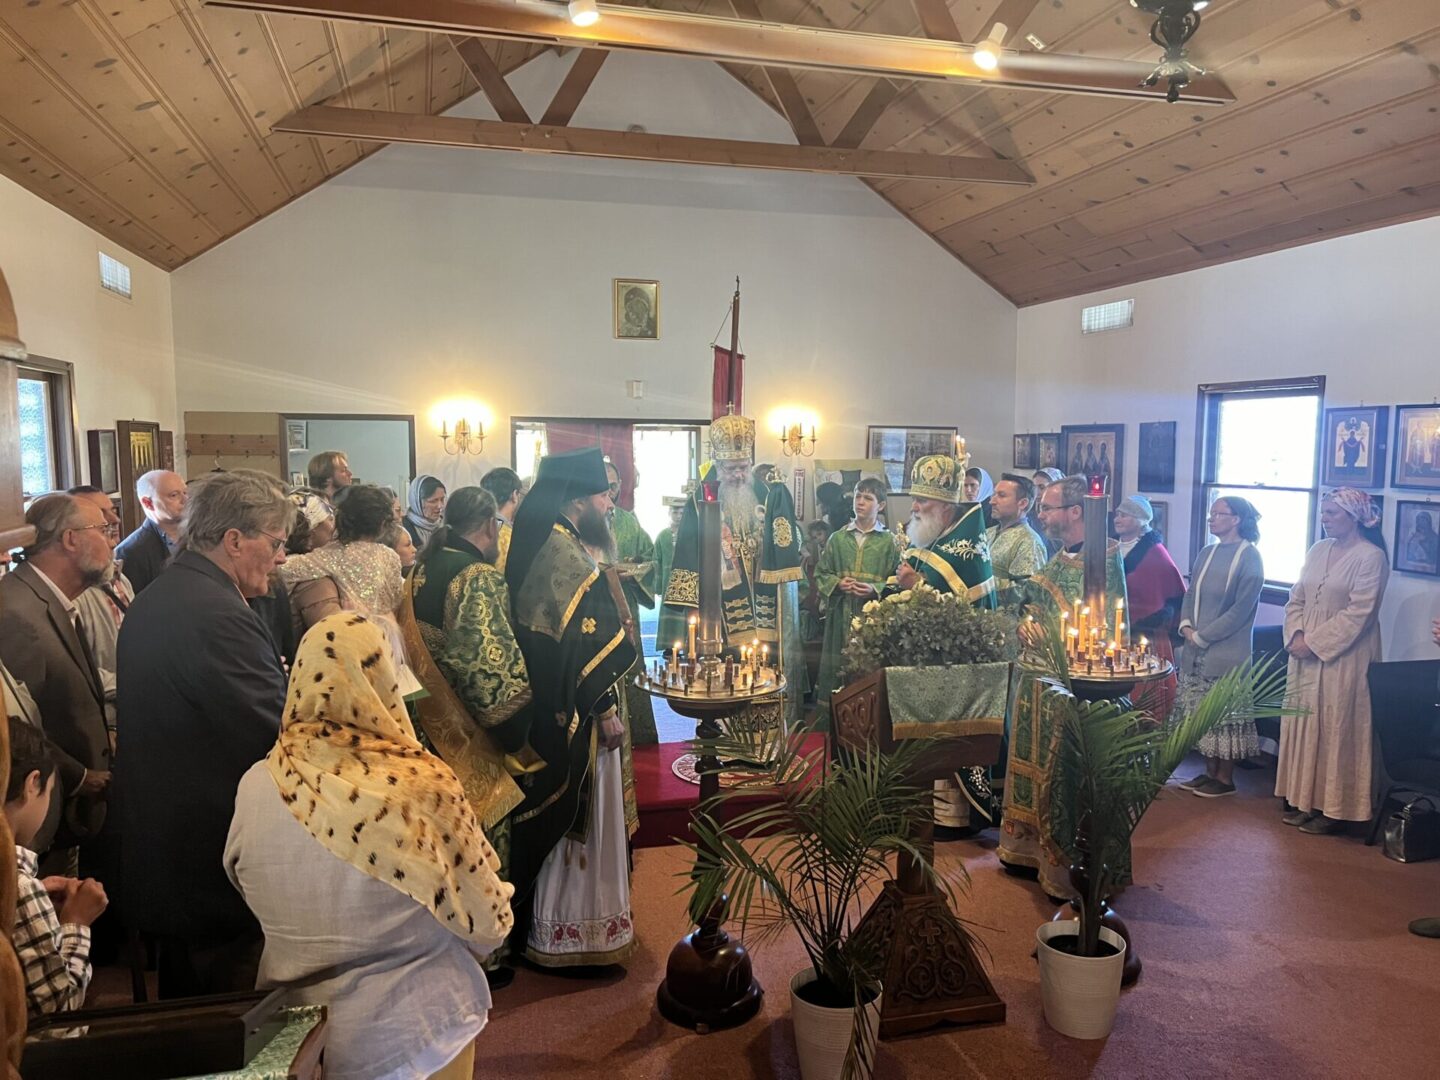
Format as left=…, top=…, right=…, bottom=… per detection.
left=0, top=177, right=179, bottom=472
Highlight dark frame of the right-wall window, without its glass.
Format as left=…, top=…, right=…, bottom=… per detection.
left=1189, top=374, right=1325, bottom=603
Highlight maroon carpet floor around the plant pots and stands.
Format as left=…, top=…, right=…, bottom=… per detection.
left=475, top=769, right=1440, bottom=1080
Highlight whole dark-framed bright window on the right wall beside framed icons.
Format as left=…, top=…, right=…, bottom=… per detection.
left=1191, top=376, right=1325, bottom=602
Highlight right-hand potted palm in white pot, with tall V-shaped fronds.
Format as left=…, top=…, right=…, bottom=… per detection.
left=1030, top=632, right=1295, bottom=1038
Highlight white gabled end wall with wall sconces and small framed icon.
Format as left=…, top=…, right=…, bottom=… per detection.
left=173, top=53, right=1015, bottom=498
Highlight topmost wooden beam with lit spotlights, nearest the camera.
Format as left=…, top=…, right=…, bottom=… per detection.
left=209, top=0, right=1234, bottom=105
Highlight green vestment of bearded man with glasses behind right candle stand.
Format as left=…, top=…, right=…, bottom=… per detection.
left=999, top=541, right=1129, bottom=897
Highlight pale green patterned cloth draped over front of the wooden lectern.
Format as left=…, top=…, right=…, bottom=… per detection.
left=886, top=661, right=1018, bottom=739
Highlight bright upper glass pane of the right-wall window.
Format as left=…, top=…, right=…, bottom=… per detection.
left=1214, top=393, right=1320, bottom=488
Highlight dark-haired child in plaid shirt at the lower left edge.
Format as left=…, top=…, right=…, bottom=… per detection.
left=4, top=716, right=108, bottom=1017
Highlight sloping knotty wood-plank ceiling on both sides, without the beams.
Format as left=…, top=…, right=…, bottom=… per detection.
left=0, top=0, right=1440, bottom=304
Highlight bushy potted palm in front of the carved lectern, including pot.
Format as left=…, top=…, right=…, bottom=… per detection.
left=685, top=726, right=963, bottom=1080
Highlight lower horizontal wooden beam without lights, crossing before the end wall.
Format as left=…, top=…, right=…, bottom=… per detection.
left=275, top=105, right=1034, bottom=184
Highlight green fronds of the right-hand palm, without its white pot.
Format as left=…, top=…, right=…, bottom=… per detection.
left=1025, top=613, right=1299, bottom=956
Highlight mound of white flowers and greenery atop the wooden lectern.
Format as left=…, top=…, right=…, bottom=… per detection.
left=844, top=585, right=1020, bottom=680
